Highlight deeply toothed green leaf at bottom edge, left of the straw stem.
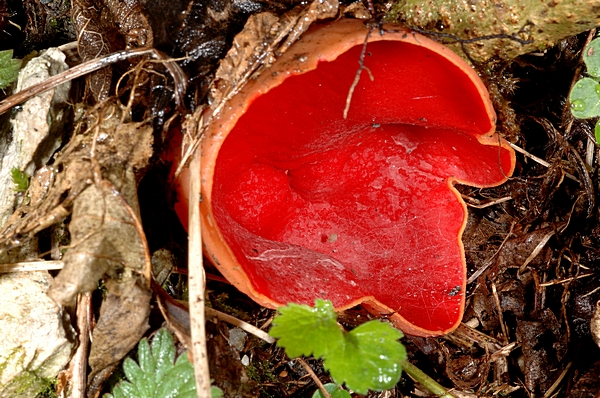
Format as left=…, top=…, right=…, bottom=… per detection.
left=104, top=329, right=223, bottom=398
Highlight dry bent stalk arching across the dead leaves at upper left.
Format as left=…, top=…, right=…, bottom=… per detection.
left=0, top=48, right=187, bottom=115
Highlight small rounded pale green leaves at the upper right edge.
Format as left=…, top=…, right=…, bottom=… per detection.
left=569, top=38, right=600, bottom=143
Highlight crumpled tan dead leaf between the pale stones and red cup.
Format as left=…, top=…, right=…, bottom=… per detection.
left=48, top=104, right=152, bottom=305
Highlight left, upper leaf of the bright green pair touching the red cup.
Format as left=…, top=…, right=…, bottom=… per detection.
left=269, top=299, right=343, bottom=358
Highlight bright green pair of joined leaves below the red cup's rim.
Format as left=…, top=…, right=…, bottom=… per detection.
left=269, top=299, right=406, bottom=398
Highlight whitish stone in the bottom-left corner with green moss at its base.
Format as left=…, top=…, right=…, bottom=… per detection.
left=0, top=271, right=74, bottom=398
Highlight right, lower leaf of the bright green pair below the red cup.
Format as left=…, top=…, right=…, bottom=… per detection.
left=324, top=321, right=406, bottom=394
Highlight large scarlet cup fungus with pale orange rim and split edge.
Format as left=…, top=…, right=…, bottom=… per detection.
left=176, top=20, right=515, bottom=336
